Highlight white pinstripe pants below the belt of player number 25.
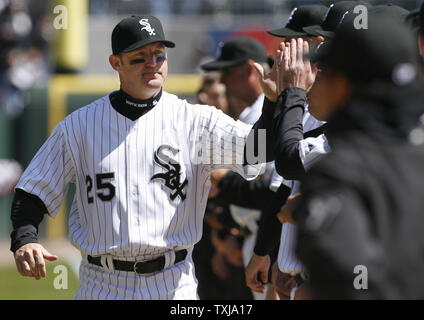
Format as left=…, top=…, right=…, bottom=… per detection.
left=75, top=254, right=199, bottom=300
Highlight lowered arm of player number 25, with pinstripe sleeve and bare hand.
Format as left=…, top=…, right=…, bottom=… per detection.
left=11, top=122, right=75, bottom=279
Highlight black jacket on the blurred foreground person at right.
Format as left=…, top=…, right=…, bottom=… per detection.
left=294, top=83, right=424, bottom=299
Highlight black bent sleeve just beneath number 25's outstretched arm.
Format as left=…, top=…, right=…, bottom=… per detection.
left=218, top=171, right=273, bottom=210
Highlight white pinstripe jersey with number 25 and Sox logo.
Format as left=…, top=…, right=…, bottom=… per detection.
left=17, top=92, right=262, bottom=260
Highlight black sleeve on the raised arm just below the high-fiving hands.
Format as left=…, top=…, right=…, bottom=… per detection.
left=275, top=88, right=306, bottom=180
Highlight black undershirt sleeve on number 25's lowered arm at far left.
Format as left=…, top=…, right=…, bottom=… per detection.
left=10, top=189, right=47, bottom=252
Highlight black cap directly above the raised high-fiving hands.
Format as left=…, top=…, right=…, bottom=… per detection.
left=267, top=4, right=327, bottom=37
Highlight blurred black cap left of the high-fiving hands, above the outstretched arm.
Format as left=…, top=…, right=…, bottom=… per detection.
left=200, top=36, right=269, bottom=71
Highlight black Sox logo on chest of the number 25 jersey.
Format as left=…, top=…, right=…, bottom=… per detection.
left=150, top=145, right=188, bottom=201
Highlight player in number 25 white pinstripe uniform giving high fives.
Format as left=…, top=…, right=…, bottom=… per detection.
left=11, top=16, right=273, bottom=299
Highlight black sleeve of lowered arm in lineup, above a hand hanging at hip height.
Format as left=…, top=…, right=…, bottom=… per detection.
left=253, top=184, right=290, bottom=256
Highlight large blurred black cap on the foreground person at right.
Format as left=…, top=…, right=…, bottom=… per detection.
left=310, top=14, right=417, bottom=86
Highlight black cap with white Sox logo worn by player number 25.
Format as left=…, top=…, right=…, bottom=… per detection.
left=112, top=16, right=175, bottom=55
